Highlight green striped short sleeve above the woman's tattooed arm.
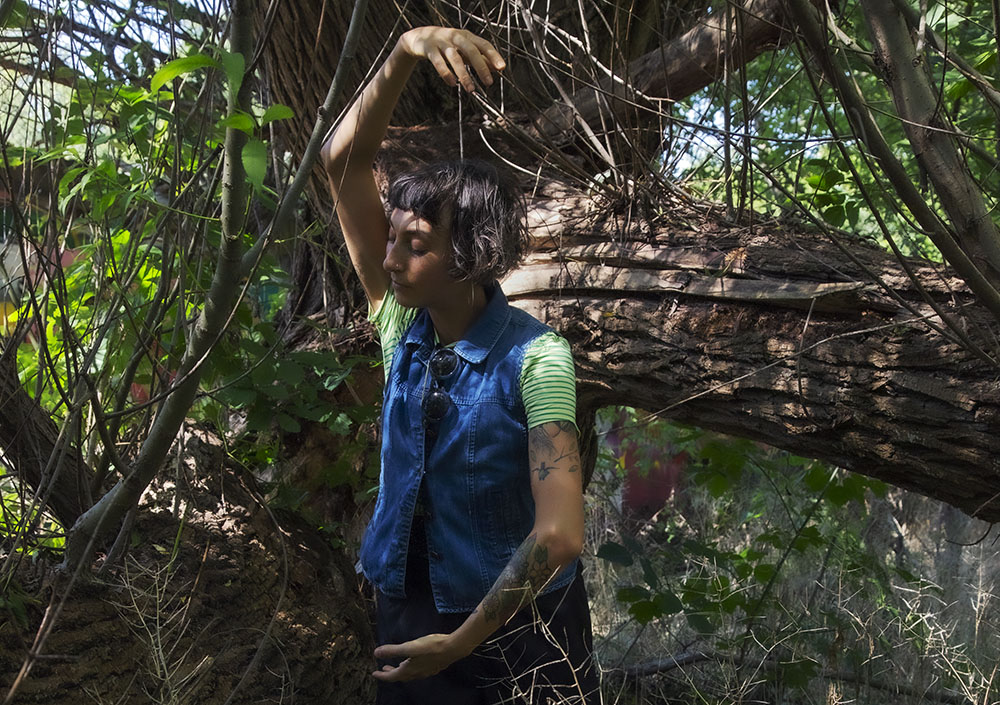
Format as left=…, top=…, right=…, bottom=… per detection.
left=521, top=333, right=576, bottom=428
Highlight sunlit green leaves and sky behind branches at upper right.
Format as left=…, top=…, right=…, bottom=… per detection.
left=665, top=2, right=1000, bottom=260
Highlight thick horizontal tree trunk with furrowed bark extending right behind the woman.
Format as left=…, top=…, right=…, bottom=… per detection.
left=505, top=183, right=1000, bottom=521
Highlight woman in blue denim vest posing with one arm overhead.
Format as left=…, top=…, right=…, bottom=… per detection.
left=323, top=27, right=600, bottom=703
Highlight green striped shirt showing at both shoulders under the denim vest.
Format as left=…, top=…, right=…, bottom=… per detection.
left=368, top=289, right=576, bottom=428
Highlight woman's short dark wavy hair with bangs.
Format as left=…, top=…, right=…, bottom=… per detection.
left=388, top=159, right=528, bottom=284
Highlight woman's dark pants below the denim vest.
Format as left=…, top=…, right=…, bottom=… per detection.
left=375, top=522, right=601, bottom=705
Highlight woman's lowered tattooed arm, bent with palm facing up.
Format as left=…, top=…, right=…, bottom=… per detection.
left=374, top=421, right=583, bottom=681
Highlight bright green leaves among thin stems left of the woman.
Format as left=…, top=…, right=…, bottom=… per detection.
left=0, top=3, right=373, bottom=568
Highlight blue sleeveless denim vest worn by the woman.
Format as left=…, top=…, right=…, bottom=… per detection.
left=361, top=285, right=577, bottom=613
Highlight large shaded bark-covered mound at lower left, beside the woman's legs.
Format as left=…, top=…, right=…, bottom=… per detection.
left=0, top=432, right=373, bottom=705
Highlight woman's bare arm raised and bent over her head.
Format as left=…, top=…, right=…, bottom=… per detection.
left=322, top=27, right=505, bottom=308
